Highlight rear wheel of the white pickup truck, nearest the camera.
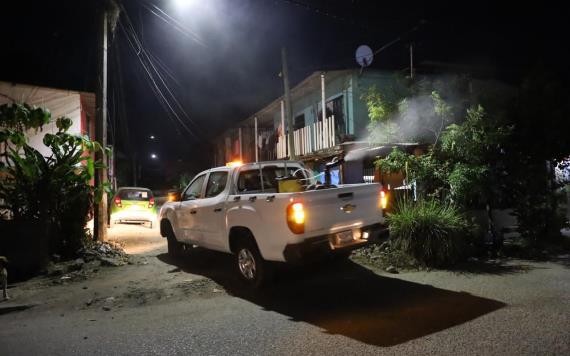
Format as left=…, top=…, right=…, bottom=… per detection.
left=235, top=238, right=271, bottom=288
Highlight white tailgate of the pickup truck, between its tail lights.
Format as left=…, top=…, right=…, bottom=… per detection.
left=301, top=183, right=384, bottom=235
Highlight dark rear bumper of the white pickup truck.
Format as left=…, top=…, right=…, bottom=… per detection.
left=283, top=224, right=388, bottom=264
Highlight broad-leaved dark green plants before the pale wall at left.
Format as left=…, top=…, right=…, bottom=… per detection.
left=0, top=106, right=108, bottom=256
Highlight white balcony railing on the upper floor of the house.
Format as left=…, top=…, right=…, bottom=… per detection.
left=277, top=116, right=337, bottom=159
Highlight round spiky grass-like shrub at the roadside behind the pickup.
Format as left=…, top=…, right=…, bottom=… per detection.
left=388, top=199, right=468, bottom=266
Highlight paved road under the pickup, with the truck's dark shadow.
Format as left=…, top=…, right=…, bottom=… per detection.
left=0, top=226, right=570, bottom=355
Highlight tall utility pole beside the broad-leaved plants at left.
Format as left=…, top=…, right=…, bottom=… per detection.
left=93, top=3, right=108, bottom=241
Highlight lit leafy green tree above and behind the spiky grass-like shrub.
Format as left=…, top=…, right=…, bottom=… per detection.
left=376, top=101, right=511, bottom=208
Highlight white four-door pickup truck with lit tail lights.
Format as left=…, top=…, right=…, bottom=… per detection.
left=159, top=161, right=387, bottom=286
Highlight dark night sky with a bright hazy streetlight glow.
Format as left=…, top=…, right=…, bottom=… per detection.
left=0, top=0, right=570, bottom=188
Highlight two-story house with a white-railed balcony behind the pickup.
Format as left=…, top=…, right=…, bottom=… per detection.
left=214, top=69, right=404, bottom=183
